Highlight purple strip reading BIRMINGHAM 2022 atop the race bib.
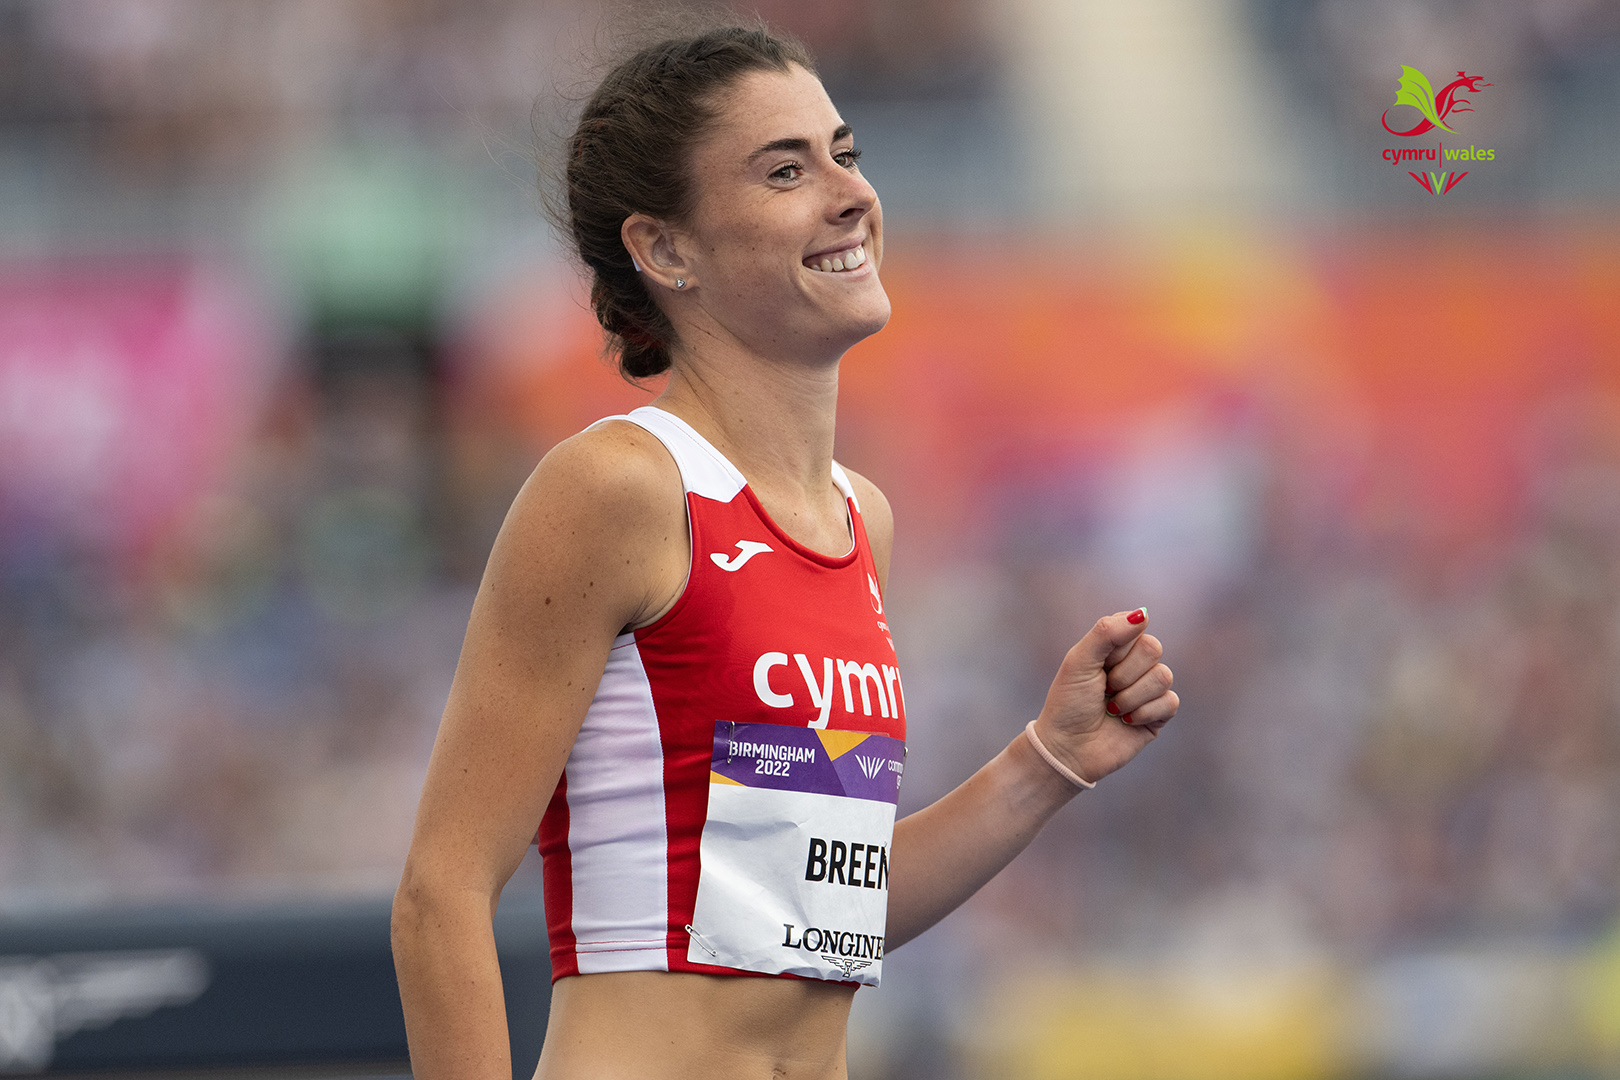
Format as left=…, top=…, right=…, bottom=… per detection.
left=710, top=721, right=906, bottom=803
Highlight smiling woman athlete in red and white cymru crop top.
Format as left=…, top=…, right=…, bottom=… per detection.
left=394, top=29, right=1178, bottom=1080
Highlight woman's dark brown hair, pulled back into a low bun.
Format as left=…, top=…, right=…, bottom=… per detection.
left=551, top=24, right=815, bottom=379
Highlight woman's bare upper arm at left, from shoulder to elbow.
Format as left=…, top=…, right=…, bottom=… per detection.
left=410, top=424, right=687, bottom=895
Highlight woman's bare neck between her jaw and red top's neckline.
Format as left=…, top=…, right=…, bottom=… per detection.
left=654, top=343, right=838, bottom=497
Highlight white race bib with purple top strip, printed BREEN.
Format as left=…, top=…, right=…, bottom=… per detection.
left=687, top=721, right=906, bottom=986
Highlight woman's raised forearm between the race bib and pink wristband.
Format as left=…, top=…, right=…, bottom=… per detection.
left=888, top=735, right=1079, bottom=949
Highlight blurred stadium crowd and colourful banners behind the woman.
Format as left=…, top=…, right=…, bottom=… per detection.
left=0, top=0, right=1620, bottom=1080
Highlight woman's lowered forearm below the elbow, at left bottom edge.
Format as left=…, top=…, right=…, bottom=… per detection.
left=392, top=873, right=512, bottom=1080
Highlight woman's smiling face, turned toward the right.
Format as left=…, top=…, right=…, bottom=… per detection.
left=676, top=66, right=889, bottom=369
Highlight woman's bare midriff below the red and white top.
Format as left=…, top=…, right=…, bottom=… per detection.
left=534, top=972, right=855, bottom=1080
